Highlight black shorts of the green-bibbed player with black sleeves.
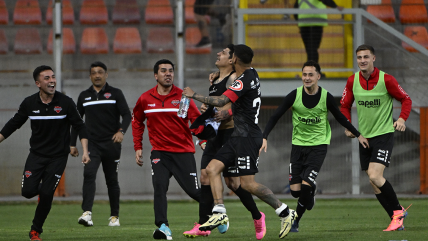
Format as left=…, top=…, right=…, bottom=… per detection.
left=289, top=144, right=327, bottom=187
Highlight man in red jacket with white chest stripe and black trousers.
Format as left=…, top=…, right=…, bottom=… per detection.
left=132, top=59, right=200, bottom=240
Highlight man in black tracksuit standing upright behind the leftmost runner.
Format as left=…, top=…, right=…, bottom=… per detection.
left=70, top=62, right=132, bottom=226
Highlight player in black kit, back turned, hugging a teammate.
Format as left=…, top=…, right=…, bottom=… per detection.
left=183, top=44, right=296, bottom=238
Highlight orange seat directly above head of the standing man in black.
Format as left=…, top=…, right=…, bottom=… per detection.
left=80, top=28, right=109, bottom=54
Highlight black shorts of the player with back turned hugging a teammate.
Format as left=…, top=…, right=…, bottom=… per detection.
left=214, top=137, right=263, bottom=176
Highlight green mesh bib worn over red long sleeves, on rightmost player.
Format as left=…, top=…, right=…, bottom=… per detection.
left=353, top=71, right=394, bottom=138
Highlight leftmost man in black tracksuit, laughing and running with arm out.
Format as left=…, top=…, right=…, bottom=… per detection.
left=0, top=65, right=90, bottom=240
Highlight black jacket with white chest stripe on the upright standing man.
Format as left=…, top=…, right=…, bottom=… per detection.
left=70, top=83, right=132, bottom=146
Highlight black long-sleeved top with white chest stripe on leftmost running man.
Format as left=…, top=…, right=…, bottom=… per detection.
left=0, top=91, right=88, bottom=157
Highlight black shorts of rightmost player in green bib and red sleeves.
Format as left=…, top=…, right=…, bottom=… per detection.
left=360, top=132, right=394, bottom=171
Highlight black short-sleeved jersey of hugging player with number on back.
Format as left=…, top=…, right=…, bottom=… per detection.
left=224, top=68, right=262, bottom=137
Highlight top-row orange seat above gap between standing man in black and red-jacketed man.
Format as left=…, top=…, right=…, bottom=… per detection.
left=112, top=0, right=141, bottom=24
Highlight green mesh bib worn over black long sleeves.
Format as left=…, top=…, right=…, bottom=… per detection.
left=291, top=86, right=331, bottom=146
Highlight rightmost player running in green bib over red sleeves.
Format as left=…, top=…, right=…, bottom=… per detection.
left=340, top=44, right=412, bottom=231
